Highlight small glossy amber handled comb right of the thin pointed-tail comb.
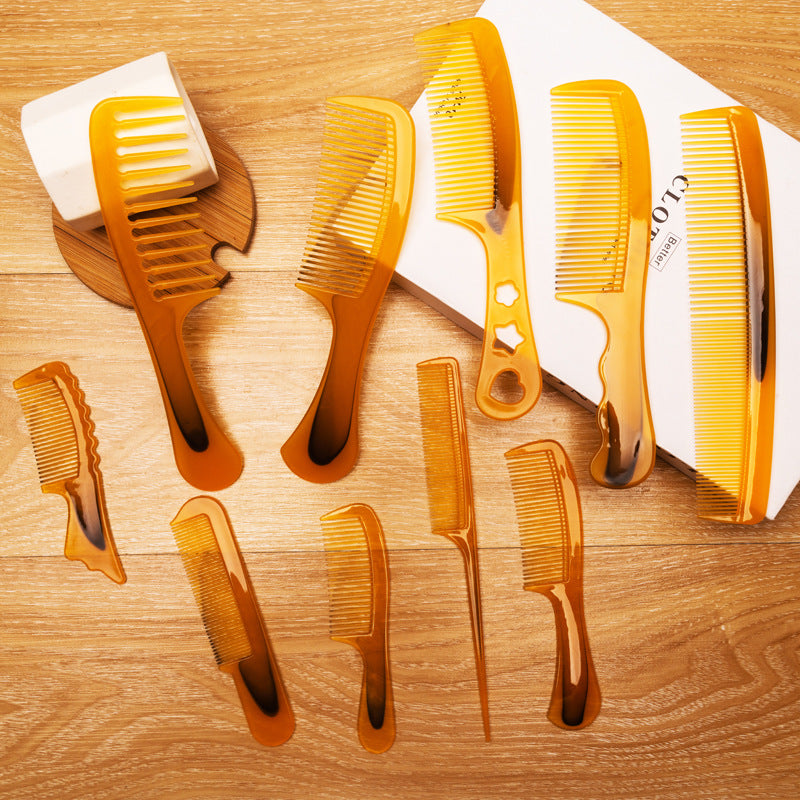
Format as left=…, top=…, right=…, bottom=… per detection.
left=506, top=441, right=601, bottom=729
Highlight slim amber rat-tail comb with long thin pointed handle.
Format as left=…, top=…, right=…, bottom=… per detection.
left=417, top=358, right=491, bottom=742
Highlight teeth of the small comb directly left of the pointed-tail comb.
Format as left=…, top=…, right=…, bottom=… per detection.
left=322, top=517, right=373, bottom=637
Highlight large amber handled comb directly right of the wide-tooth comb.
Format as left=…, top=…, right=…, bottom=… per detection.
left=281, top=97, right=414, bottom=483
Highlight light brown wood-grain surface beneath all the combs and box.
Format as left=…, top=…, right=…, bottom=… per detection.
left=0, top=0, right=800, bottom=800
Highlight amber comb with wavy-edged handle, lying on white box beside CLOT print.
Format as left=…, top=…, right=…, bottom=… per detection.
left=551, top=80, right=656, bottom=488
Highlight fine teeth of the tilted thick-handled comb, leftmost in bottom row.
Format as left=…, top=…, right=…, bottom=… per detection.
left=171, top=514, right=252, bottom=665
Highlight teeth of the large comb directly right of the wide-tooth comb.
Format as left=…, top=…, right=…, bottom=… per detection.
left=298, top=101, right=397, bottom=297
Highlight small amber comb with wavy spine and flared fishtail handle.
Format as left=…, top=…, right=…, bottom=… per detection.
left=14, top=361, right=126, bottom=583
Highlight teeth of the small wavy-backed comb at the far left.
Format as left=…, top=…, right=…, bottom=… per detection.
left=16, top=380, right=80, bottom=487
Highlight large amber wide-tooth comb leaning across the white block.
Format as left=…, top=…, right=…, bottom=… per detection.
left=89, top=97, right=242, bottom=491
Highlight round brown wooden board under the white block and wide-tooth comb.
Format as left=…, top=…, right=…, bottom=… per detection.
left=53, top=130, right=255, bottom=307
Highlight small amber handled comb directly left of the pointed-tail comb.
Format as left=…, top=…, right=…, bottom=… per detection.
left=320, top=503, right=395, bottom=753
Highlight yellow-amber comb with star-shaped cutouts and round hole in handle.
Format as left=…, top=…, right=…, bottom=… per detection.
left=414, top=17, right=542, bottom=419
